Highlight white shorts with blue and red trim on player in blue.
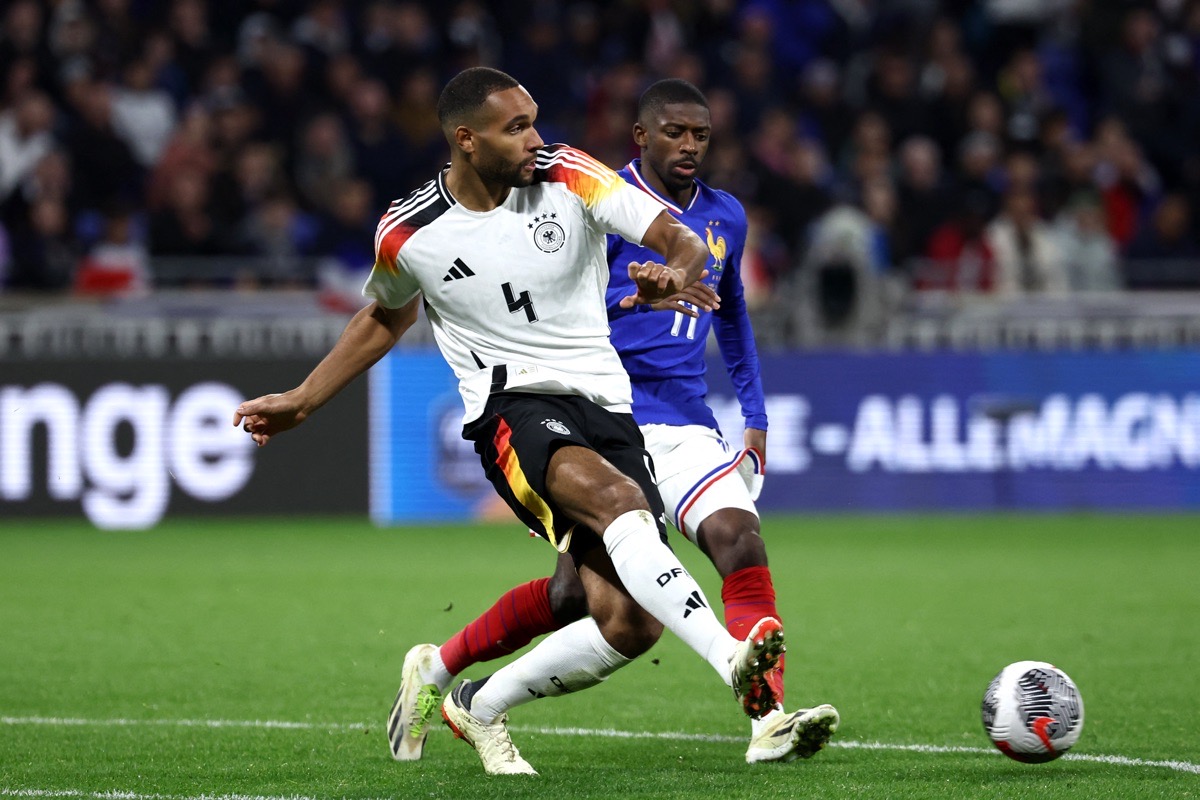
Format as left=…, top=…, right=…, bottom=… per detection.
left=642, top=425, right=758, bottom=543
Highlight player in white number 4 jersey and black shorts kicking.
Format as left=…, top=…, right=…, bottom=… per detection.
left=234, top=67, right=784, bottom=775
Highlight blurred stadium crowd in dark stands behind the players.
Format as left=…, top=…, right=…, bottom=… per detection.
left=0, top=0, right=1200, bottom=303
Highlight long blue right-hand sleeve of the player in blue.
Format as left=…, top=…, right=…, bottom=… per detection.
left=713, top=204, right=767, bottom=431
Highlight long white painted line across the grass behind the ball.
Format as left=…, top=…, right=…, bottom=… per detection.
left=0, top=716, right=1200, bottom=772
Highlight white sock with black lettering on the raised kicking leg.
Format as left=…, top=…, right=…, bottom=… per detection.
left=604, top=511, right=738, bottom=685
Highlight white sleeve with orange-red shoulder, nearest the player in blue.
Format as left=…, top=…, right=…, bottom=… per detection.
left=538, top=144, right=666, bottom=245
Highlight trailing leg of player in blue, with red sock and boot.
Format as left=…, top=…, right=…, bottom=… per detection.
left=388, top=553, right=588, bottom=760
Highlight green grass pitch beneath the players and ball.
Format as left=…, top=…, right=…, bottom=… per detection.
left=0, top=515, right=1200, bottom=800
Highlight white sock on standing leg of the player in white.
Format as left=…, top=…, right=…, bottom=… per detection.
left=470, top=616, right=632, bottom=724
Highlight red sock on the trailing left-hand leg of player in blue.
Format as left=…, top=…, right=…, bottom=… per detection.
left=442, top=578, right=563, bottom=675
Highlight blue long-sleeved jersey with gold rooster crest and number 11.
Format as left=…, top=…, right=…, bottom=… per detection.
left=607, top=158, right=767, bottom=431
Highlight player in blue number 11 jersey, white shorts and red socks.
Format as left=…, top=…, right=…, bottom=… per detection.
left=388, top=79, right=839, bottom=763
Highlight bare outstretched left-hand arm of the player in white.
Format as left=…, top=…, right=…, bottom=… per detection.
left=233, top=295, right=420, bottom=447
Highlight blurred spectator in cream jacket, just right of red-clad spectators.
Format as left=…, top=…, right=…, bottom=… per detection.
left=986, top=186, right=1068, bottom=297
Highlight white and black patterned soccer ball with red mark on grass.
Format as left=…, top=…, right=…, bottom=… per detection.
left=983, top=661, right=1084, bottom=764
